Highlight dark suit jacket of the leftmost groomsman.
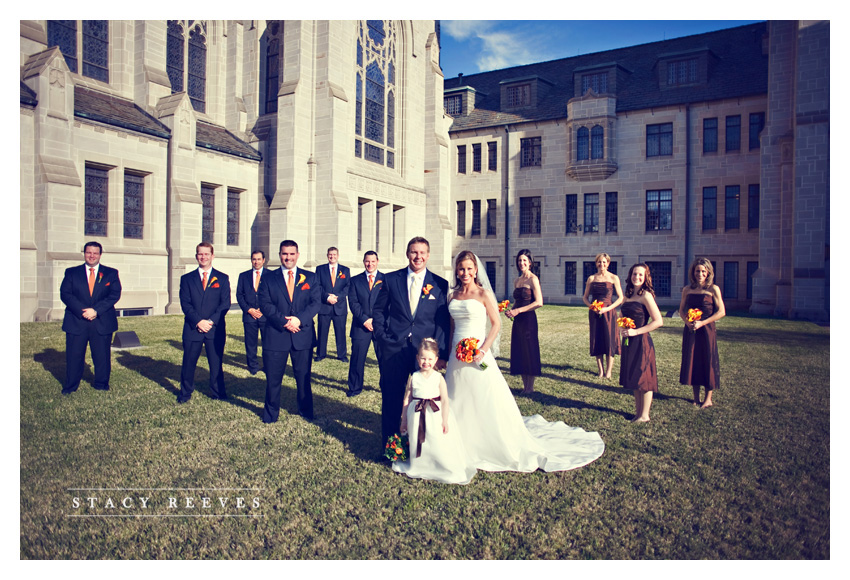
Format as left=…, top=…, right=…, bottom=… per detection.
left=59, top=264, right=121, bottom=334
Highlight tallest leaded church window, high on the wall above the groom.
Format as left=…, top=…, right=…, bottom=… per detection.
left=354, top=20, right=398, bottom=169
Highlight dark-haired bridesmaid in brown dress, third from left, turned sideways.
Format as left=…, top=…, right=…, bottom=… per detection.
left=620, top=264, right=664, bottom=423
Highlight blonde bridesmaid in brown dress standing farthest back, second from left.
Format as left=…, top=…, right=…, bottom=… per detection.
left=582, top=253, right=623, bottom=379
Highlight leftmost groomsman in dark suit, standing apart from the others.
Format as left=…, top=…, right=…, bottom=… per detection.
left=59, top=242, right=121, bottom=395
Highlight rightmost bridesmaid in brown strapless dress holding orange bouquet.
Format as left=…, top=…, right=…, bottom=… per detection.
left=679, top=258, right=726, bottom=409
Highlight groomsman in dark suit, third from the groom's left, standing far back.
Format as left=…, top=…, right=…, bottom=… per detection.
left=316, top=248, right=351, bottom=362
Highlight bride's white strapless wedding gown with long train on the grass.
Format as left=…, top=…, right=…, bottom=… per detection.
left=446, top=300, right=605, bottom=472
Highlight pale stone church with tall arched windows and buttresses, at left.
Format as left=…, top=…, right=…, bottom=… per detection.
left=20, top=20, right=452, bottom=321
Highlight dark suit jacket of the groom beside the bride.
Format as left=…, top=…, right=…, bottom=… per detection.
left=372, top=268, right=451, bottom=360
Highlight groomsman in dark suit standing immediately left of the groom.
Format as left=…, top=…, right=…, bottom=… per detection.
left=346, top=250, right=384, bottom=397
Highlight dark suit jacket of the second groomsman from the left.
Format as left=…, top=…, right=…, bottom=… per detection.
left=180, top=268, right=230, bottom=342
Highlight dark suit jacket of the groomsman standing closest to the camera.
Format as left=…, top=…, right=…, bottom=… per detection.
left=258, top=268, right=321, bottom=351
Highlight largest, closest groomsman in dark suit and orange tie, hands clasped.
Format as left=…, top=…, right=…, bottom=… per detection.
left=259, top=240, right=322, bottom=423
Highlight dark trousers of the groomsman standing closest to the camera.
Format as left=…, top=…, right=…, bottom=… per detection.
left=263, top=348, right=313, bottom=423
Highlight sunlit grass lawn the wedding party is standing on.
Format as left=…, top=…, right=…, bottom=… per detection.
left=20, top=306, right=830, bottom=560
